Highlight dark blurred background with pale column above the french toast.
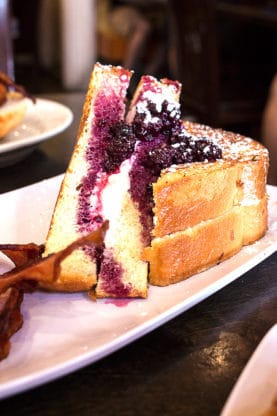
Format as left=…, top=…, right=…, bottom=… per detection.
left=1, top=0, right=277, bottom=182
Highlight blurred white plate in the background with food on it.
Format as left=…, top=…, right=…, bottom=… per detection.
left=0, top=98, right=73, bottom=167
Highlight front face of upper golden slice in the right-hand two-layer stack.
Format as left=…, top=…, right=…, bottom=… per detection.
left=153, top=160, right=243, bottom=237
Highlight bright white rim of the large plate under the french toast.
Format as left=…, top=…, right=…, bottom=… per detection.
left=0, top=175, right=277, bottom=399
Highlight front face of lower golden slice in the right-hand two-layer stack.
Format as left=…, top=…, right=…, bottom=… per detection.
left=144, top=207, right=243, bottom=286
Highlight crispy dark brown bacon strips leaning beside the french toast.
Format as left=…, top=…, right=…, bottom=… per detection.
left=0, top=221, right=108, bottom=360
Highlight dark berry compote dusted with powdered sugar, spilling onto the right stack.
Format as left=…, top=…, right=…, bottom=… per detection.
left=130, top=101, right=222, bottom=243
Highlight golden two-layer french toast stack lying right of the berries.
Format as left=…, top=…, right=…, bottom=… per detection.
left=143, top=122, right=269, bottom=286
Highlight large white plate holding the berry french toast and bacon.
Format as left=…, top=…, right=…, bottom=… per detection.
left=0, top=176, right=277, bottom=398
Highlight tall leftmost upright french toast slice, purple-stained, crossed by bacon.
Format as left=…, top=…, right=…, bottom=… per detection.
left=44, top=64, right=131, bottom=291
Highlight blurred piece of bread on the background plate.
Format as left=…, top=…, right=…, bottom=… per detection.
left=0, top=92, right=27, bottom=139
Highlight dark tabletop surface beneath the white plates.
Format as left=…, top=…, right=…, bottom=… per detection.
left=0, top=93, right=277, bottom=416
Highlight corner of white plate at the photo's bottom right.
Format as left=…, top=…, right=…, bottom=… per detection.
left=221, top=325, right=277, bottom=416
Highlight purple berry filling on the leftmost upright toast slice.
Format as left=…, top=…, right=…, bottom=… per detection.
left=77, top=93, right=132, bottom=232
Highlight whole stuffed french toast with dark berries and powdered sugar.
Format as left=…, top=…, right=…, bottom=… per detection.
left=44, top=64, right=268, bottom=298
